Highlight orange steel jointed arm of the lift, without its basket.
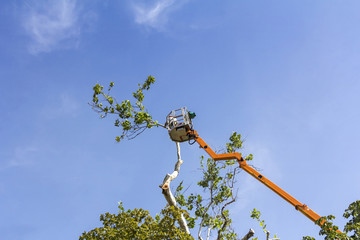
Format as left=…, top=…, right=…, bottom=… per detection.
left=189, top=131, right=322, bottom=225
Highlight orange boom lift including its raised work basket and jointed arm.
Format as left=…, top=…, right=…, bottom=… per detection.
left=165, top=107, right=320, bottom=225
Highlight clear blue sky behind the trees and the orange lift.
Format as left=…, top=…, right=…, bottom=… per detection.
left=0, top=0, right=360, bottom=240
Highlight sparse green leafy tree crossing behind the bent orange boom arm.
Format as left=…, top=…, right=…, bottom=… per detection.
left=176, top=132, right=252, bottom=239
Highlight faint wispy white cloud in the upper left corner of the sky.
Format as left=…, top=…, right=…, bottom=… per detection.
left=24, top=0, right=81, bottom=54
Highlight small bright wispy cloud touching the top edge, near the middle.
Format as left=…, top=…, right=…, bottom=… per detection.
left=132, top=0, right=181, bottom=30
